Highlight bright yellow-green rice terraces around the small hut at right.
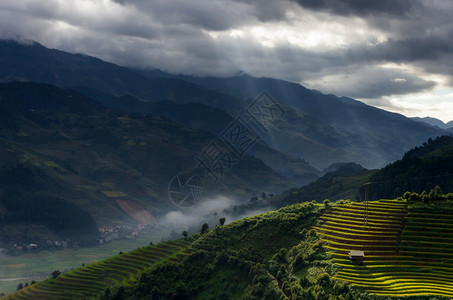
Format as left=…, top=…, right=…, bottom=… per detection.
left=315, top=200, right=453, bottom=297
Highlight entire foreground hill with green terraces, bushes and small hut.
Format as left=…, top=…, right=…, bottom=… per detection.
left=2, top=193, right=453, bottom=300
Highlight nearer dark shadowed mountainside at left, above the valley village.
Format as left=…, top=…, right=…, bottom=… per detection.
left=0, top=82, right=295, bottom=245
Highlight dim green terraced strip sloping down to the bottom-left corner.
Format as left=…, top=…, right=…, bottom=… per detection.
left=2, top=240, right=189, bottom=300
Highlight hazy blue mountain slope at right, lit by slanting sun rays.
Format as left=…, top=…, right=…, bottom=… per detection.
left=164, top=74, right=447, bottom=168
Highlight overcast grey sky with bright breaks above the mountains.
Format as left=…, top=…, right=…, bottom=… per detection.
left=0, top=0, right=453, bottom=121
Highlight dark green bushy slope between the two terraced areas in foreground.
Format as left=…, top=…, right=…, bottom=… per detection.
left=96, top=202, right=368, bottom=299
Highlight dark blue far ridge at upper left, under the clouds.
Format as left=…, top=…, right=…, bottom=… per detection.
left=0, top=40, right=243, bottom=110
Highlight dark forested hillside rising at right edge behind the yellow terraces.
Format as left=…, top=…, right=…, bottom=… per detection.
left=268, top=136, right=453, bottom=206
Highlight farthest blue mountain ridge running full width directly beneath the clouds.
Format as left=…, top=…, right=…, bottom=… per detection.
left=0, top=41, right=447, bottom=170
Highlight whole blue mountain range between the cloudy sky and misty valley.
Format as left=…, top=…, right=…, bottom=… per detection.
left=0, top=40, right=448, bottom=243
